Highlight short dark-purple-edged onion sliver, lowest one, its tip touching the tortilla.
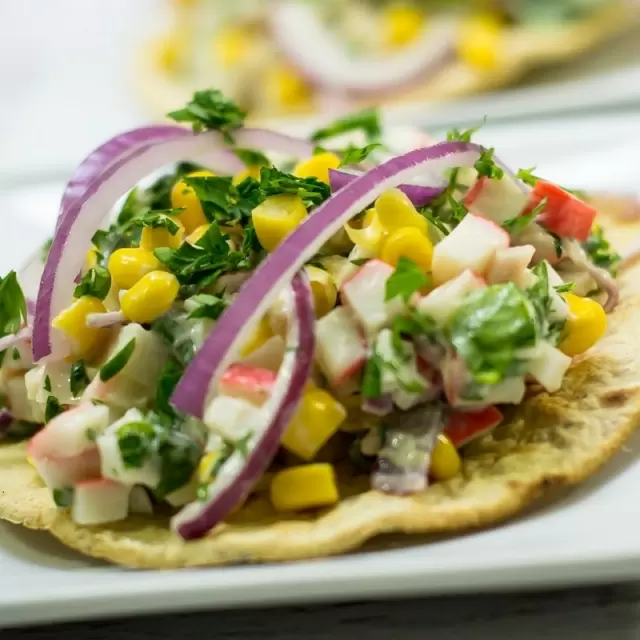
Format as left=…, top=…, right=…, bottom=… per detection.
left=171, top=272, right=315, bottom=540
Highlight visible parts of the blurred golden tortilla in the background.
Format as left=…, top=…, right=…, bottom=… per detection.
left=134, top=0, right=638, bottom=120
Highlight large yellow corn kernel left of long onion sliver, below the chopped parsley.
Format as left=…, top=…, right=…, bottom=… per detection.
left=251, top=193, right=307, bottom=251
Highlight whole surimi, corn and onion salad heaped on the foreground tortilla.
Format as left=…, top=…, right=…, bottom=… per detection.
left=0, top=90, right=619, bottom=539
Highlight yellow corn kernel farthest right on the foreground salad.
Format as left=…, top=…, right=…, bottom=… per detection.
left=558, top=293, right=607, bottom=356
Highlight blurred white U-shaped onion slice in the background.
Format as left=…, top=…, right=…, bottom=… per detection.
left=268, top=0, right=455, bottom=94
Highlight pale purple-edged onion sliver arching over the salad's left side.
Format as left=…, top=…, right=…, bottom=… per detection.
left=33, top=127, right=232, bottom=361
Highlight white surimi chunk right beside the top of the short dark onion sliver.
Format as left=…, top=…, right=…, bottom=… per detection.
left=316, top=307, right=367, bottom=386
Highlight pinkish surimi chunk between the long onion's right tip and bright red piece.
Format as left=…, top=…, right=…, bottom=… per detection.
left=464, top=175, right=529, bottom=224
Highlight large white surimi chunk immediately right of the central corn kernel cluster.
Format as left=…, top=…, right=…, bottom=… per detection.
left=432, top=214, right=509, bottom=284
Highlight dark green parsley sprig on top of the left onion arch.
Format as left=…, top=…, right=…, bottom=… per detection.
left=168, top=89, right=247, bottom=142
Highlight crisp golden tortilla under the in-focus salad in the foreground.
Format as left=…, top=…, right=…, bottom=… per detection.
left=0, top=205, right=640, bottom=568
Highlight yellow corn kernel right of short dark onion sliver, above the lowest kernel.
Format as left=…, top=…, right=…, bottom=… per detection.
left=282, top=388, right=347, bottom=461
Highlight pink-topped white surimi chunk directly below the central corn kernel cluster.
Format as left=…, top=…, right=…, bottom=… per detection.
left=341, top=260, right=404, bottom=336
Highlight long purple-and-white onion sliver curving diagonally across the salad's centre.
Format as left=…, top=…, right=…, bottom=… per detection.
left=172, top=142, right=483, bottom=418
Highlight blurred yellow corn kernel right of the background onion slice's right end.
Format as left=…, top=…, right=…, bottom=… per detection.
left=457, top=13, right=504, bottom=70
